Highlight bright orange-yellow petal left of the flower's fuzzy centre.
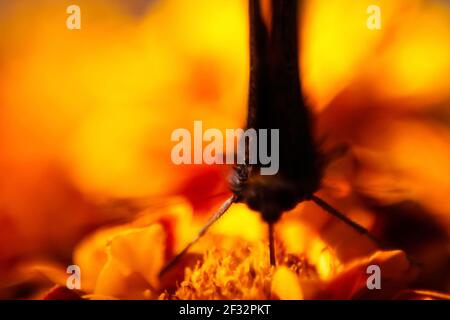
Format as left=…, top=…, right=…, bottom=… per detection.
left=74, top=199, right=192, bottom=299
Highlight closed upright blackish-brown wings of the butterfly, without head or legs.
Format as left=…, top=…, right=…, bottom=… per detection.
left=247, top=0, right=321, bottom=193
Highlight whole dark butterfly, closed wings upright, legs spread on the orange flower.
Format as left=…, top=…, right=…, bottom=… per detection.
left=160, top=0, right=383, bottom=275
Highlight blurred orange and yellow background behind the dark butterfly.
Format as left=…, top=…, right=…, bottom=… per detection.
left=0, top=0, right=450, bottom=298
